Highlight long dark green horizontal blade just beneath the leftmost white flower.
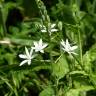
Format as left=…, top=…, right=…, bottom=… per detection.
left=0, top=64, right=51, bottom=72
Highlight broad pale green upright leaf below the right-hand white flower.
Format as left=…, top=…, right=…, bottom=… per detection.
left=53, top=55, right=69, bottom=79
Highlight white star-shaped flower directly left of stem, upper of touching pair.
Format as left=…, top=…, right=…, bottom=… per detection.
left=32, top=39, right=48, bottom=53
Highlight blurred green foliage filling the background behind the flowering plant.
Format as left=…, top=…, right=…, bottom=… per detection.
left=0, top=0, right=96, bottom=96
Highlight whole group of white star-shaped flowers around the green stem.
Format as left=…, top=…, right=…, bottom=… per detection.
left=19, top=24, right=78, bottom=66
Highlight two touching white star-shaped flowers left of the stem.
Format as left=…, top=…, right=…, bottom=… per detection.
left=19, top=39, right=48, bottom=66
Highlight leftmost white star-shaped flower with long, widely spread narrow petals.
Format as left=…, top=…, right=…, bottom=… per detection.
left=19, top=47, right=36, bottom=66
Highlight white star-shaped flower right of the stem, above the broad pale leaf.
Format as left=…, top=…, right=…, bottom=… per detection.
left=61, top=39, right=78, bottom=55
